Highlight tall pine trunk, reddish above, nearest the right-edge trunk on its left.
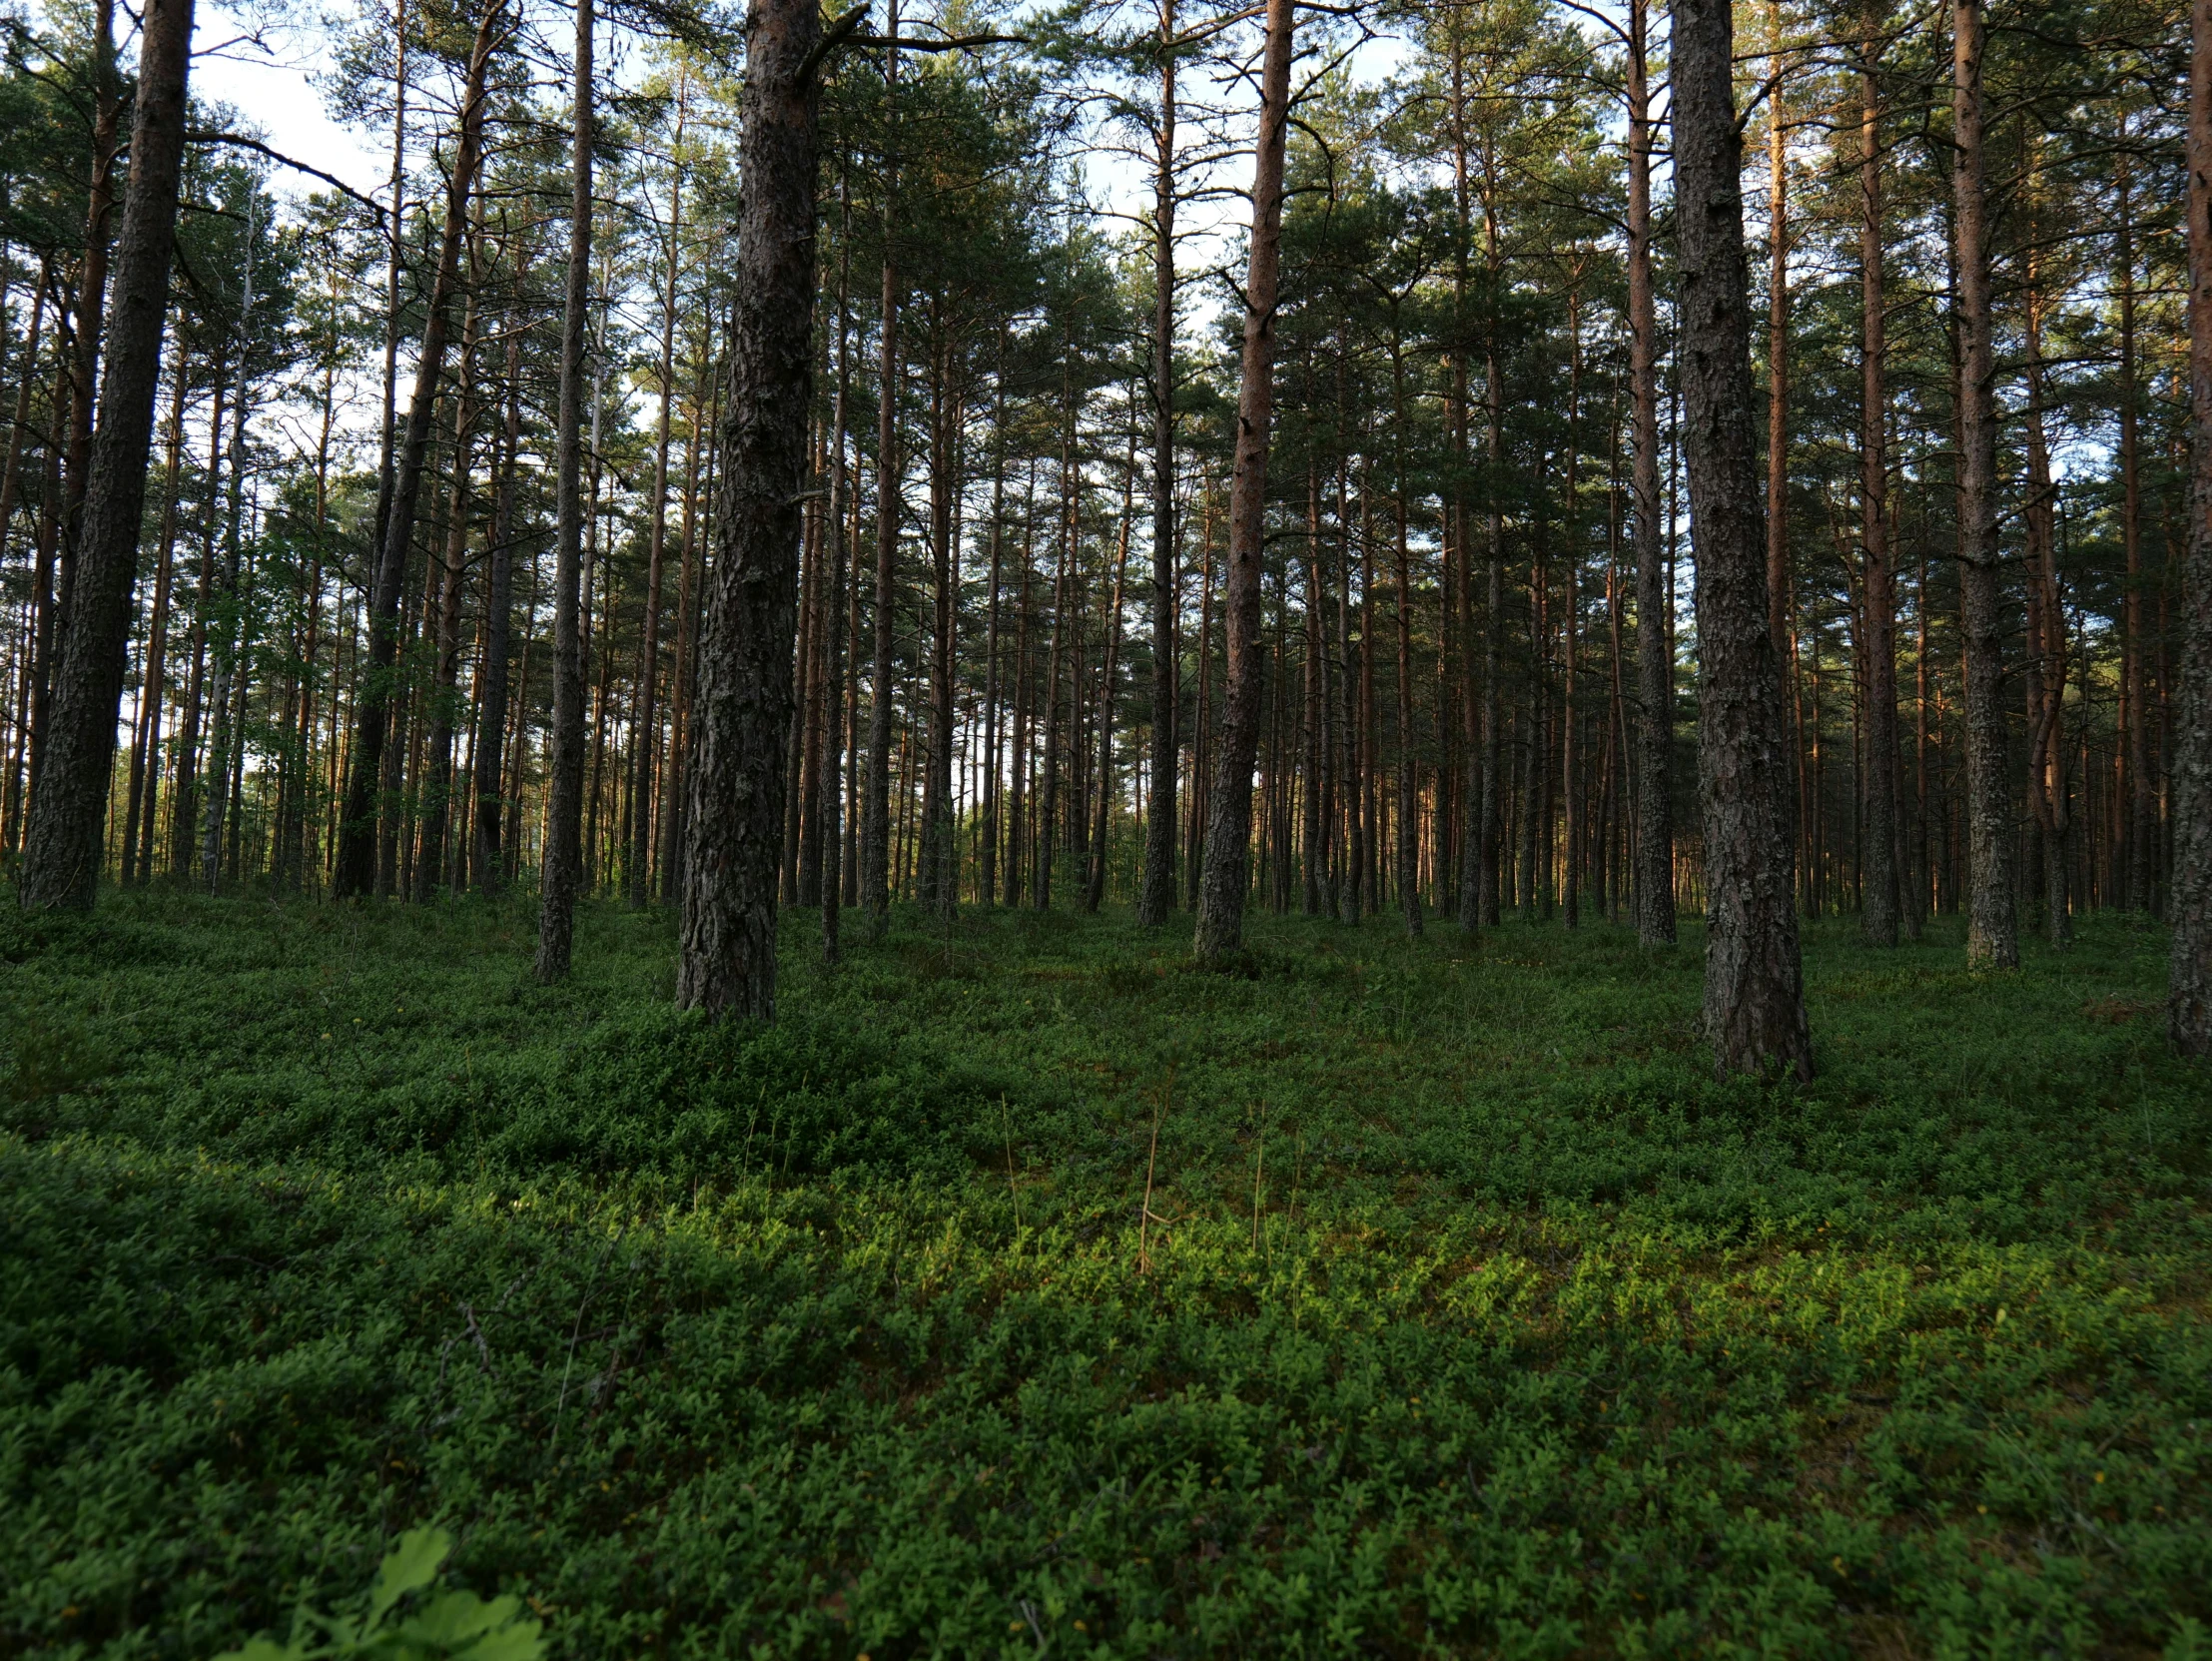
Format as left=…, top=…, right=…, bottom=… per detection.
left=1951, top=0, right=2019, bottom=969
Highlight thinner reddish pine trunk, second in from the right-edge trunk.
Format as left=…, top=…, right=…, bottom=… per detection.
left=1857, top=35, right=1900, bottom=947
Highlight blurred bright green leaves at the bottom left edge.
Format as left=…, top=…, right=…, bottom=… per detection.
left=215, top=1528, right=546, bottom=1661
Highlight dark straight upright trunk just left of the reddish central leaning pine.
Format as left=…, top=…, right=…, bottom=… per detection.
left=1137, top=0, right=1181, bottom=929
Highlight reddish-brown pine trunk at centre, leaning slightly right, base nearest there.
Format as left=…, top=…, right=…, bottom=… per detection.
left=1196, top=0, right=1294, bottom=962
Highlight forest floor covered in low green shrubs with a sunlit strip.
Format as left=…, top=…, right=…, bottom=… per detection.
left=0, top=894, right=2212, bottom=1661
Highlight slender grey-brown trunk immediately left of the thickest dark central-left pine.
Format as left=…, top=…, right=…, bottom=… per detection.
left=537, top=0, right=593, bottom=980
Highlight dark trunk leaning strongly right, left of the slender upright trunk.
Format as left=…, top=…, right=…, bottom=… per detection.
left=332, top=0, right=504, bottom=898
